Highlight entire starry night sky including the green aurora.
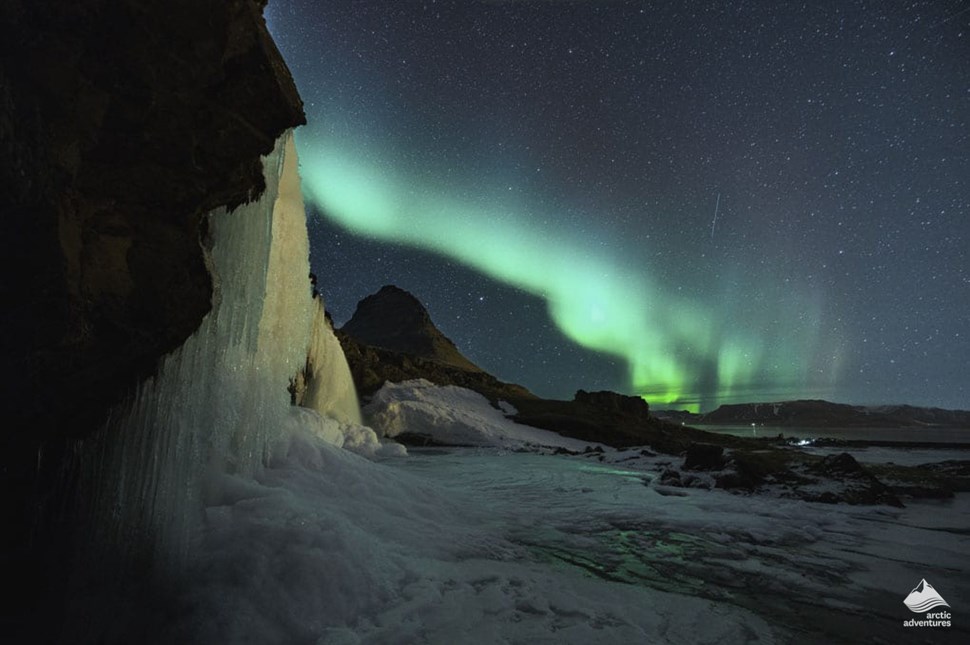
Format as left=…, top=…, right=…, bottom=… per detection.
left=266, top=0, right=970, bottom=410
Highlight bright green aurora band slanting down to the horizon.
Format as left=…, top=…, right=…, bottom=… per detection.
left=298, top=131, right=838, bottom=412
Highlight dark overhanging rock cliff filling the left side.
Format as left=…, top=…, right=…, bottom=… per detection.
left=0, top=0, right=304, bottom=641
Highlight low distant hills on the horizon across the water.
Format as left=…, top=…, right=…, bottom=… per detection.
left=657, top=400, right=970, bottom=429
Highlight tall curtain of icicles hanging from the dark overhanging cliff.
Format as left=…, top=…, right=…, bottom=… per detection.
left=78, top=132, right=318, bottom=576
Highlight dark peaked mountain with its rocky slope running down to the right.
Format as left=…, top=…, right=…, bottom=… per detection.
left=337, top=286, right=928, bottom=505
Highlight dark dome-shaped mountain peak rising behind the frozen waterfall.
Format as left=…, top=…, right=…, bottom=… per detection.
left=341, top=285, right=482, bottom=372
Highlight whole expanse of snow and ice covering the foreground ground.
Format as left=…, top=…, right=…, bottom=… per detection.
left=155, top=420, right=970, bottom=644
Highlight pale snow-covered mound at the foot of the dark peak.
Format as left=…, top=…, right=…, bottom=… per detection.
left=364, top=379, right=598, bottom=451
